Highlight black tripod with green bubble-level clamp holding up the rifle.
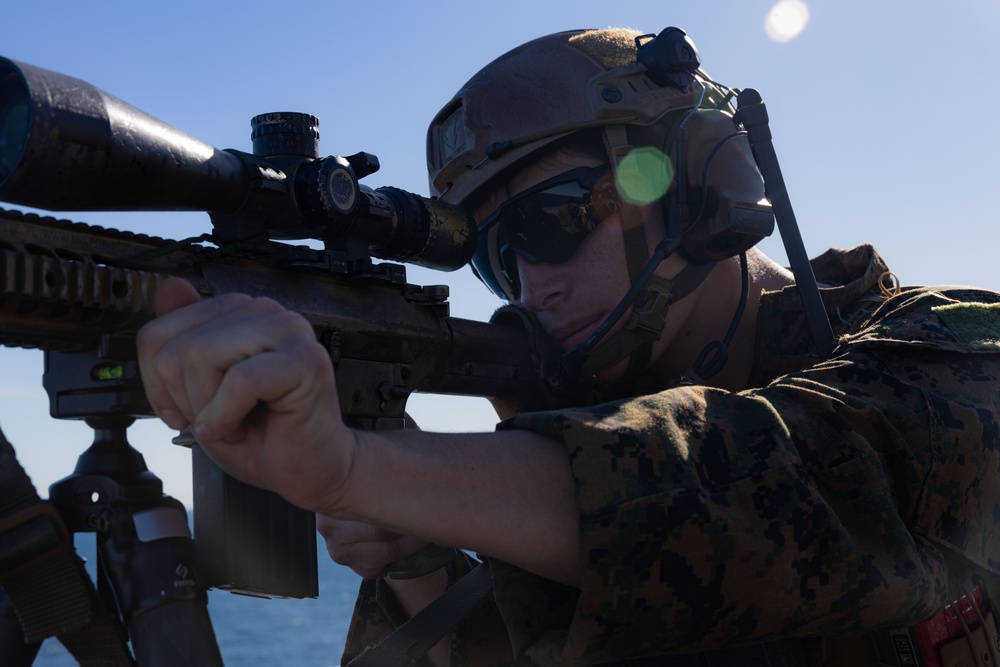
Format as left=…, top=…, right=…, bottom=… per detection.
left=0, top=336, right=222, bottom=667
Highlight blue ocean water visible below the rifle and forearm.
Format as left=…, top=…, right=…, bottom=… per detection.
left=28, top=520, right=361, bottom=667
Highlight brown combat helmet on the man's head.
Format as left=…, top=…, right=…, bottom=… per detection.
left=427, top=29, right=726, bottom=206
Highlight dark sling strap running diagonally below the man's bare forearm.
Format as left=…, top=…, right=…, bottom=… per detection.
left=347, top=563, right=493, bottom=667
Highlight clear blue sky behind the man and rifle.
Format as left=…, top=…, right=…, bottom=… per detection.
left=0, top=0, right=1000, bottom=502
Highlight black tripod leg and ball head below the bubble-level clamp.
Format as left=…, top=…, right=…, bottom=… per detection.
left=50, top=415, right=222, bottom=667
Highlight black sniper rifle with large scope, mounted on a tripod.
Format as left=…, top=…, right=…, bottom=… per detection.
left=0, top=58, right=585, bottom=664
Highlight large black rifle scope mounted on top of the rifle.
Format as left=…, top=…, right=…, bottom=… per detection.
left=0, top=58, right=476, bottom=270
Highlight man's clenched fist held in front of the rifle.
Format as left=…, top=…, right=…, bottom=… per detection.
left=138, top=278, right=356, bottom=509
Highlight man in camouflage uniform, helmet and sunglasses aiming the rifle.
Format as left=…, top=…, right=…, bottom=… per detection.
left=140, top=31, right=1000, bottom=666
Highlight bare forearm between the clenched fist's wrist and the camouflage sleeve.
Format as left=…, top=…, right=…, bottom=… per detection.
left=330, top=431, right=581, bottom=585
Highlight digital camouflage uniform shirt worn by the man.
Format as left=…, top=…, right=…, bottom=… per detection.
left=345, top=246, right=1000, bottom=666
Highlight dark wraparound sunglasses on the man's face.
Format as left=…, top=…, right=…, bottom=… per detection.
left=472, top=164, right=621, bottom=301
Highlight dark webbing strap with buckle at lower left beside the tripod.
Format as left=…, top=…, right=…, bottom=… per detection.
left=0, top=433, right=135, bottom=667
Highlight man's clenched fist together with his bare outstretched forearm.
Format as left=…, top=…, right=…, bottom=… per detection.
left=138, top=279, right=582, bottom=585
